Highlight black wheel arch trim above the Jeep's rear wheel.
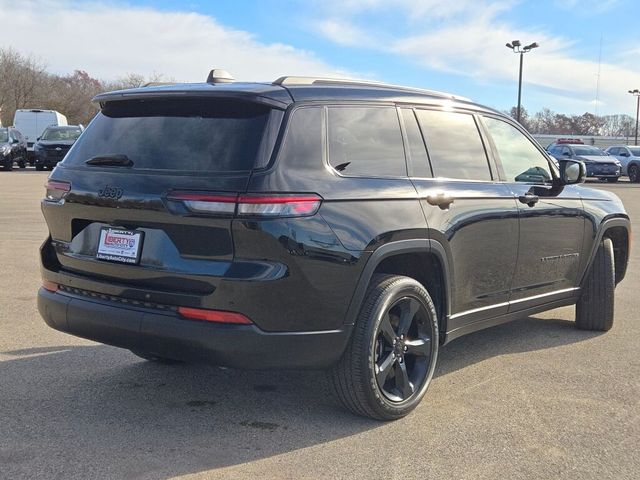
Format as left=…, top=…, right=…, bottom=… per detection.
left=346, top=239, right=452, bottom=343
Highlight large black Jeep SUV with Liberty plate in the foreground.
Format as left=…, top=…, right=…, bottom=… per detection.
left=38, top=72, right=630, bottom=419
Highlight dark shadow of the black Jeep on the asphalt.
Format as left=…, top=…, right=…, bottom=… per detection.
left=0, top=310, right=596, bottom=479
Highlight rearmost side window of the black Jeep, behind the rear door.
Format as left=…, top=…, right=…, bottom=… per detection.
left=328, top=107, right=407, bottom=176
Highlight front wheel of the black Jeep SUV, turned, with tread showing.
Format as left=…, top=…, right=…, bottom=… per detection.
left=576, top=238, right=616, bottom=331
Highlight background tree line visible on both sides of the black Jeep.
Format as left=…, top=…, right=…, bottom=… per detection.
left=0, top=48, right=635, bottom=137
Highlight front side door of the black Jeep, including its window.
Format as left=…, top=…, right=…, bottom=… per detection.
left=482, top=115, right=585, bottom=310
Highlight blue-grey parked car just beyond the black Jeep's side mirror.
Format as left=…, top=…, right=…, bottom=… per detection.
left=547, top=142, right=622, bottom=183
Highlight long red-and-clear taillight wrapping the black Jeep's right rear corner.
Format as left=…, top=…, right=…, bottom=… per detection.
left=167, top=192, right=322, bottom=218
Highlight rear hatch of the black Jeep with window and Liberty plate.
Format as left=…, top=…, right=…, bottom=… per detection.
left=42, top=97, right=282, bottom=303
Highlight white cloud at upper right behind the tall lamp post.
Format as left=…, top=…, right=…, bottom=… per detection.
left=312, top=0, right=640, bottom=113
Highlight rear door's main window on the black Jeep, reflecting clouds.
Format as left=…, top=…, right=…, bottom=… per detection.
left=416, top=110, right=491, bottom=180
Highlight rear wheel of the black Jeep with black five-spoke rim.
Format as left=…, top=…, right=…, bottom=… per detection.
left=330, top=275, right=439, bottom=420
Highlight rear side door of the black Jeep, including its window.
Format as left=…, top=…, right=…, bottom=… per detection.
left=402, top=108, right=518, bottom=331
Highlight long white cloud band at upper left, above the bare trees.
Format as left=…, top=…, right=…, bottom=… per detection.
left=0, top=0, right=345, bottom=81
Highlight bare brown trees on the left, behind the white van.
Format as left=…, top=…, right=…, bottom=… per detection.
left=0, top=48, right=169, bottom=126
